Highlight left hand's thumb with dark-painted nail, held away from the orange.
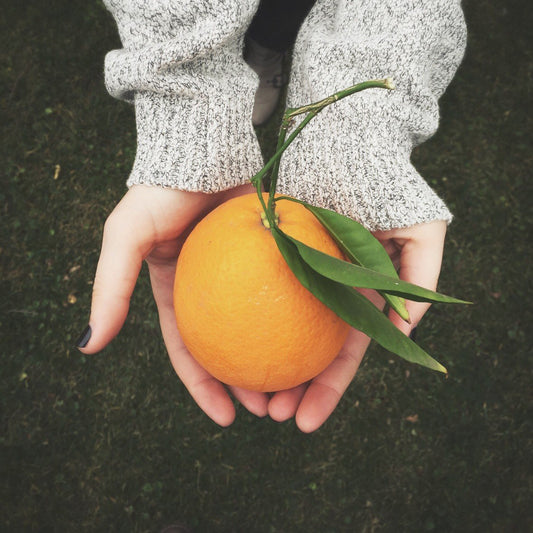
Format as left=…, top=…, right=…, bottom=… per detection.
left=76, top=203, right=153, bottom=354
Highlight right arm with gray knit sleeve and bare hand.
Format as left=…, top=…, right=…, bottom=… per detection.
left=268, top=0, right=466, bottom=432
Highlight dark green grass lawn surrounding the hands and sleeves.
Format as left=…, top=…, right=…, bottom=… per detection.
left=0, top=0, right=533, bottom=533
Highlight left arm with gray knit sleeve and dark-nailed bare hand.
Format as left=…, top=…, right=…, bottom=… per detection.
left=77, top=0, right=267, bottom=426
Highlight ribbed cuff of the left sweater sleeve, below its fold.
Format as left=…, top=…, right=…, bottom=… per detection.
left=127, top=88, right=263, bottom=193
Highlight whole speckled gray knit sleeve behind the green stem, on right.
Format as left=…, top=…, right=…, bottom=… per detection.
left=279, top=0, right=466, bottom=230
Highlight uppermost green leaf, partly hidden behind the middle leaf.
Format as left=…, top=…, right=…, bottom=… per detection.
left=280, top=196, right=409, bottom=321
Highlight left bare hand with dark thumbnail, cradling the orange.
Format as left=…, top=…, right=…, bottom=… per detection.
left=80, top=185, right=268, bottom=426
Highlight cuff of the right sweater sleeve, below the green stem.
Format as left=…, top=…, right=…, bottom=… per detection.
left=278, top=89, right=452, bottom=231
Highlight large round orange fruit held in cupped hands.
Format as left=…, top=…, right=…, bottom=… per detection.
left=174, top=194, right=349, bottom=392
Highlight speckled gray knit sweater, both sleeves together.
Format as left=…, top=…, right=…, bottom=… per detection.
left=105, top=0, right=466, bottom=230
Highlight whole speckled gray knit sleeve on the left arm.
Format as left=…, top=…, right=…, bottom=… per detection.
left=101, top=0, right=262, bottom=192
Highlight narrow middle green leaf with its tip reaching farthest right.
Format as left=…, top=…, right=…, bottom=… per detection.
left=279, top=230, right=468, bottom=303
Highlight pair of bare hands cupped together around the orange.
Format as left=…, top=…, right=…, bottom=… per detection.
left=80, top=185, right=446, bottom=432
